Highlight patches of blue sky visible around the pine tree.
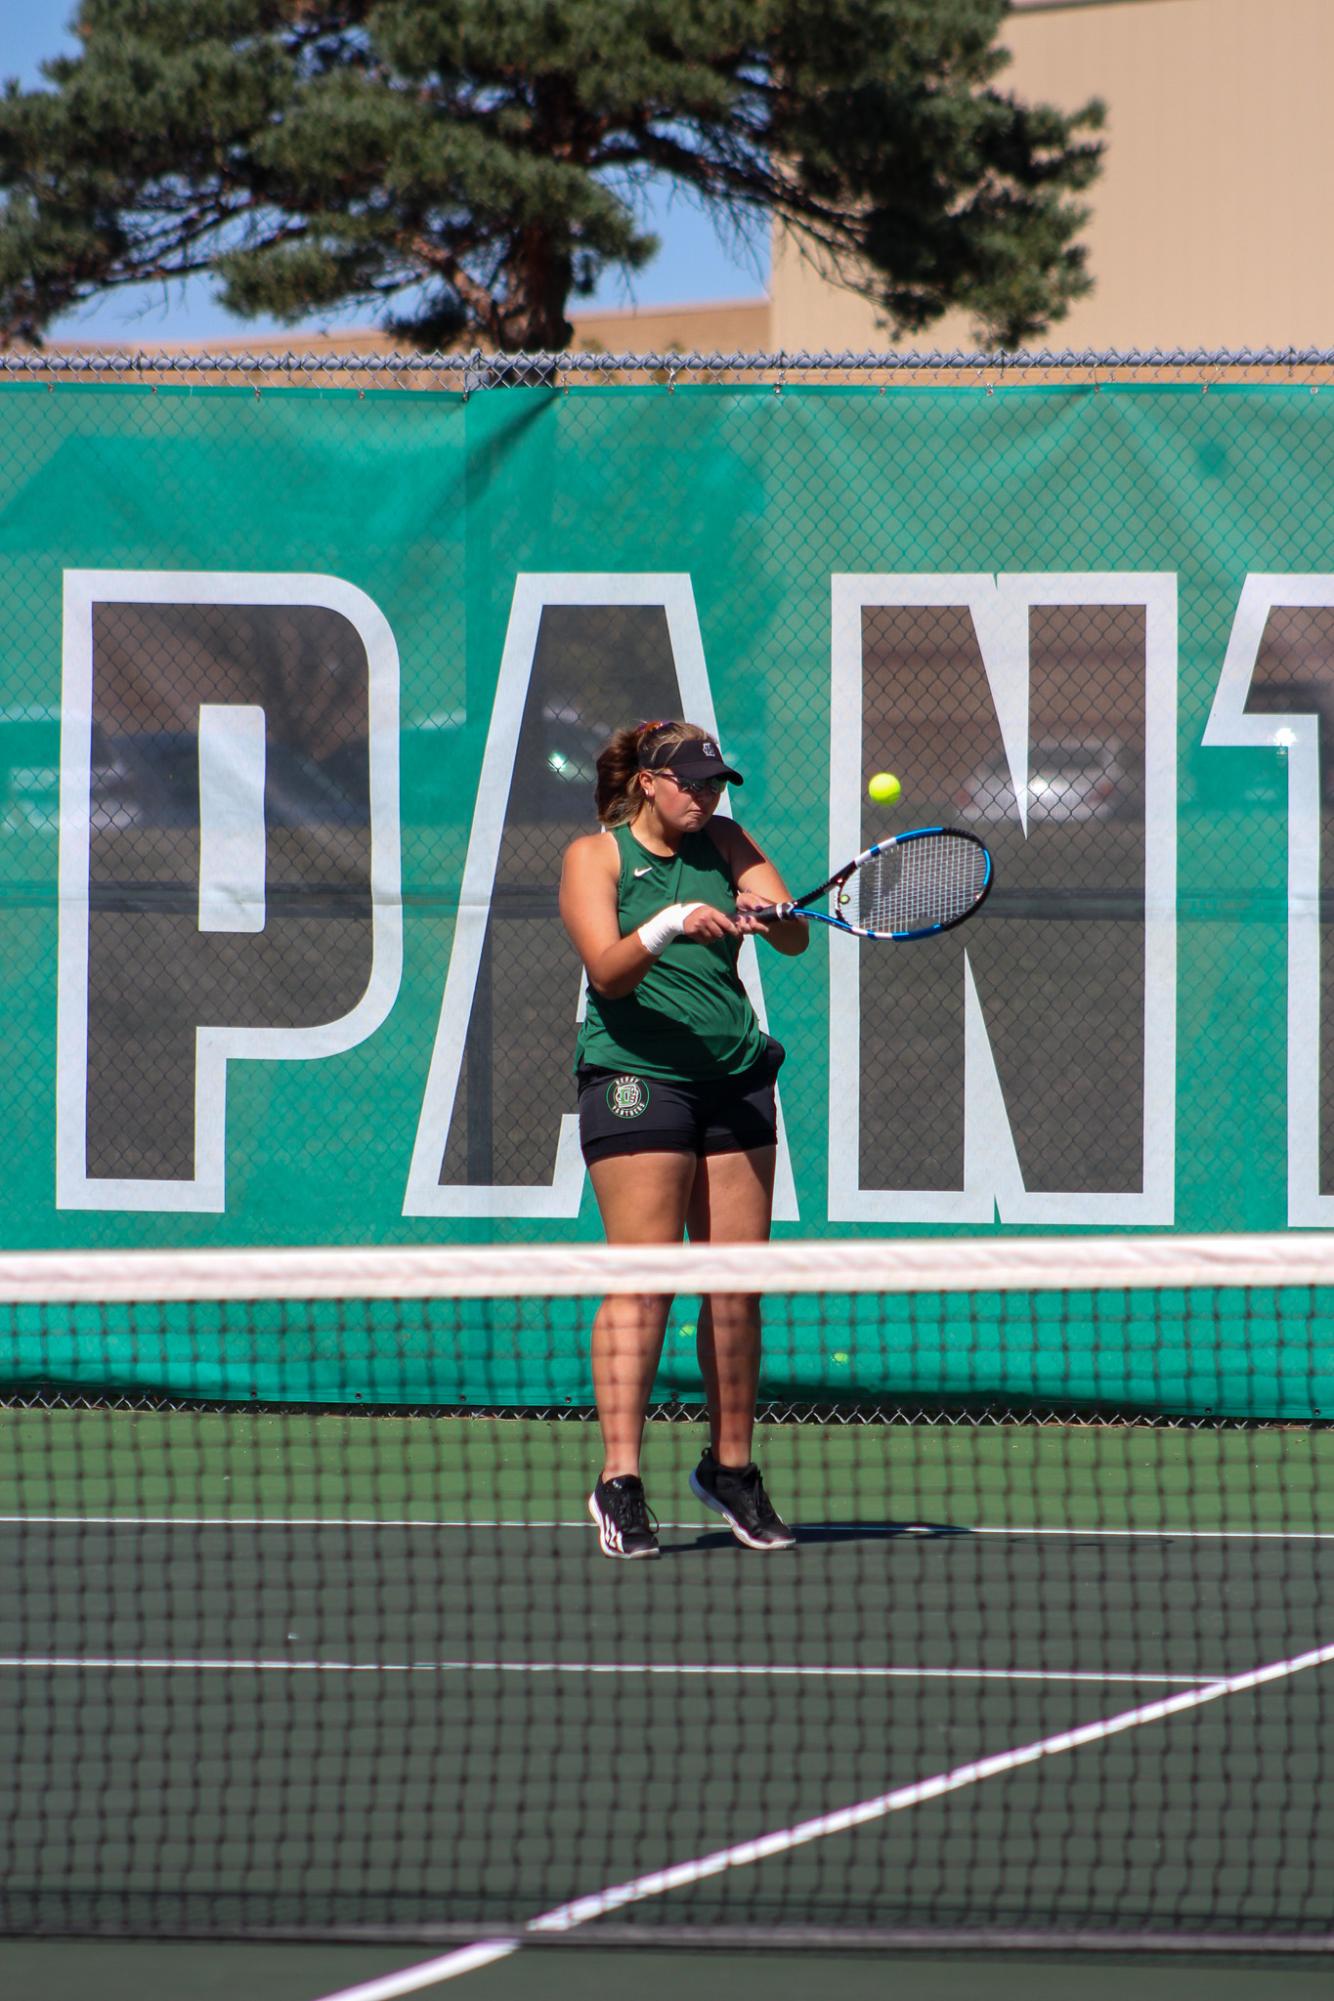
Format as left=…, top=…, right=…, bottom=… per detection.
left=0, top=0, right=768, bottom=342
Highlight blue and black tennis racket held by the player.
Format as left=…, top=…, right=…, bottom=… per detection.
left=746, top=826, right=992, bottom=940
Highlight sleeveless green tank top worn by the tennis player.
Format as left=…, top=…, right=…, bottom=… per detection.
left=574, top=826, right=764, bottom=1083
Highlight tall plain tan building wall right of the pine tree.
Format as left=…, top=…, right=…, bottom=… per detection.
left=770, top=0, right=1334, bottom=352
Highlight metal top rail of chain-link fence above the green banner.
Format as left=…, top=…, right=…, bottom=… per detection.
left=0, top=346, right=1334, bottom=376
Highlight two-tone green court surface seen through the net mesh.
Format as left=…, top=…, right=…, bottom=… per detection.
left=0, top=1409, right=1334, bottom=1944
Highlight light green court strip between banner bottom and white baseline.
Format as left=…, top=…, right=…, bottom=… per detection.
left=10, top=1409, right=1334, bottom=1535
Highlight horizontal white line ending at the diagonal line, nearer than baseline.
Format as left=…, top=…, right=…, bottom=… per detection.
left=0, top=1653, right=1218, bottom=1689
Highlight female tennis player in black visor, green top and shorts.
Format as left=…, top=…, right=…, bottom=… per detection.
left=560, top=722, right=808, bottom=1557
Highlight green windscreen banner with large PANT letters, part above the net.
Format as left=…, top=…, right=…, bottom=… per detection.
left=0, top=382, right=1334, bottom=1408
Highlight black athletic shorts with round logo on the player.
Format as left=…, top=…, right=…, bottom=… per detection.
left=578, top=1035, right=786, bottom=1165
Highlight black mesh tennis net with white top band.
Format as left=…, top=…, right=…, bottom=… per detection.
left=0, top=1237, right=1334, bottom=1951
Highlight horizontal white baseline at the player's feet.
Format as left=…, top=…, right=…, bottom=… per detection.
left=0, top=1515, right=1334, bottom=1543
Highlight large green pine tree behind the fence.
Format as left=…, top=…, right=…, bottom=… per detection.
left=0, top=0, right=1100, bottom=350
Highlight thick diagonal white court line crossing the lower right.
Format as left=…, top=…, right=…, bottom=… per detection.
left=308, top=1645, right=1334, bottom=2001
